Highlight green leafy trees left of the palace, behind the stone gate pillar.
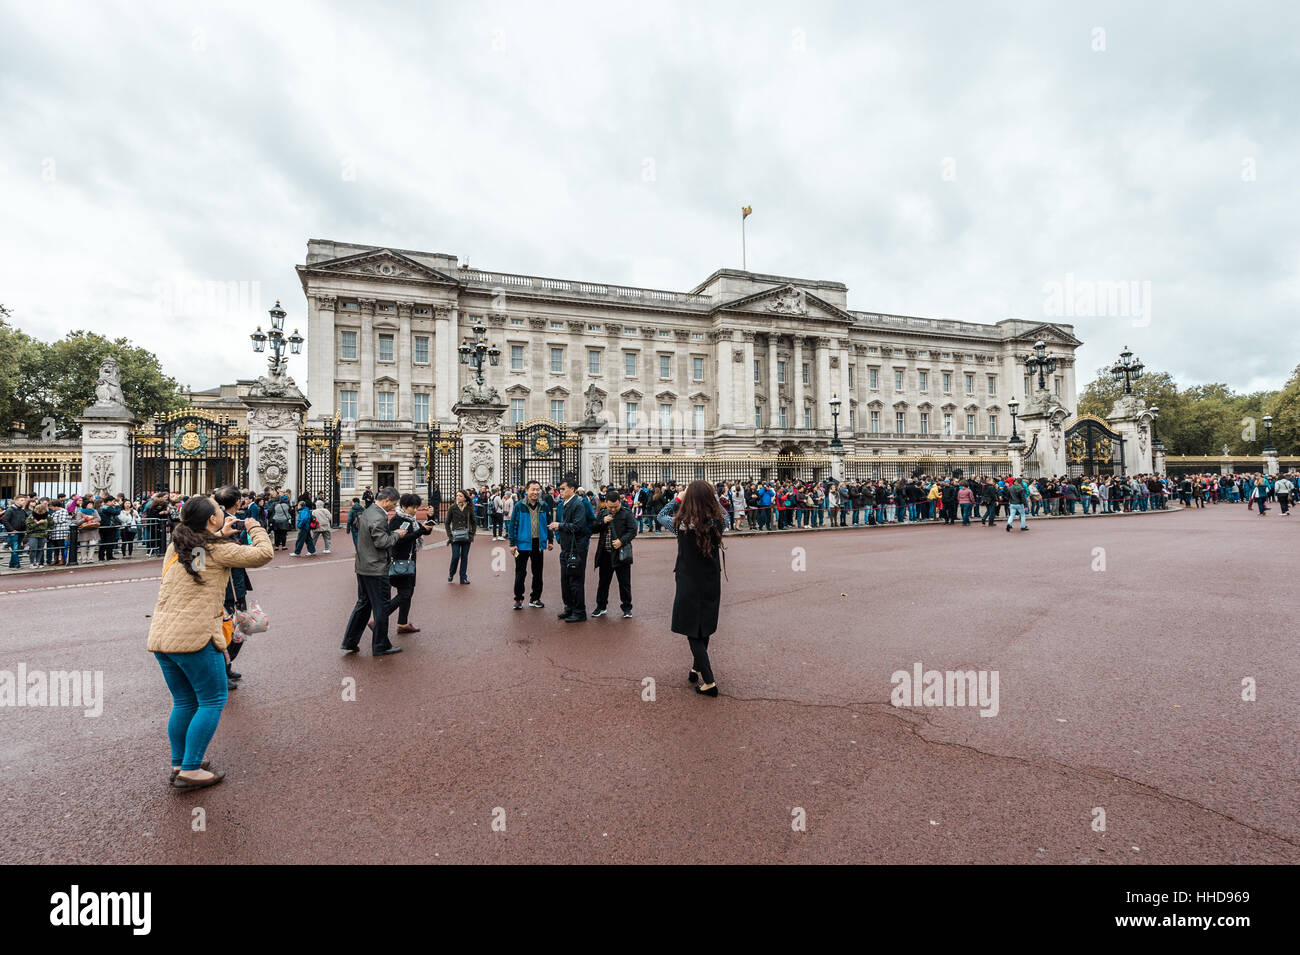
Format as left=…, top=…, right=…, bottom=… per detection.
left=0, top=321, right=185, bottom=437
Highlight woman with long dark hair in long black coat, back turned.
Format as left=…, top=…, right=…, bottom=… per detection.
left=659, top=481, right=727, bottom=696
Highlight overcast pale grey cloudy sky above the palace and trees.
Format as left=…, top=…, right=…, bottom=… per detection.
left=0, top=0, right=1300, bottom=391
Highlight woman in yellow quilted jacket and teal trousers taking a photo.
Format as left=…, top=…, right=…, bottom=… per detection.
left=148, top=496, right=274, bottom=790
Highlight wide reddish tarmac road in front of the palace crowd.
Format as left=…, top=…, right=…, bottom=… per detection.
left=0, top=504, right=1300, bottom=864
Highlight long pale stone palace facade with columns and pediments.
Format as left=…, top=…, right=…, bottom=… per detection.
left=298, top=239, right=1080, bottom=494
